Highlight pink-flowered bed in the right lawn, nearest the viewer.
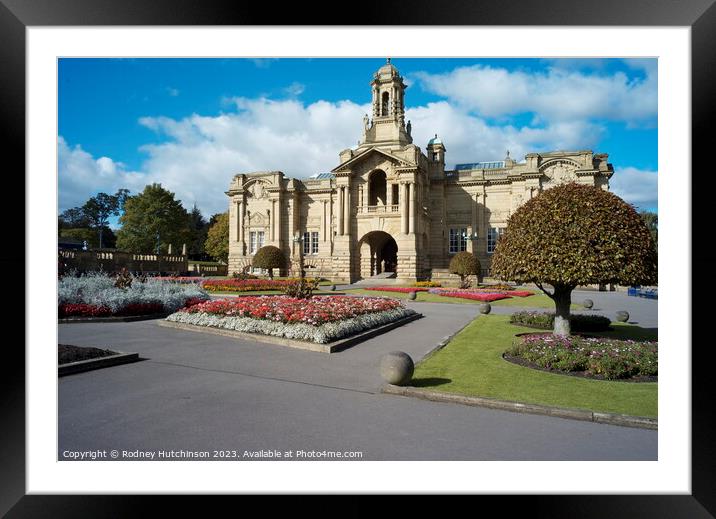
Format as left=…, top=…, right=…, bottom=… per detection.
left=505, top=334, right=658, bottom=380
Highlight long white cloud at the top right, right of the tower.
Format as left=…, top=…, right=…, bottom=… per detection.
left=416, top=60, right=657, bottom=125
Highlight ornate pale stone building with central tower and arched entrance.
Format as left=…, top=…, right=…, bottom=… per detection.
left=226, top=60, right=613, bottom=282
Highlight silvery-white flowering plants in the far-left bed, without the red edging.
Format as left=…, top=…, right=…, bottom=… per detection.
left=57, top=273, right=209, bottom=312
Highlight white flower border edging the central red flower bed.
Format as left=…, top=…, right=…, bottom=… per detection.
left=166, top=308, right=416, bottom=344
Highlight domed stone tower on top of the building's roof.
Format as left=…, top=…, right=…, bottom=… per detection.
left=361, top=58, right=413, bottom=147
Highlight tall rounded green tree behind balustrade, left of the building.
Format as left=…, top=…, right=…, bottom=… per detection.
left=117, top=184, right=192, bottom=253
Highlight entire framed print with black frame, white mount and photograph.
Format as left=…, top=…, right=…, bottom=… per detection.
left=0, top=0, right=716, bottom=517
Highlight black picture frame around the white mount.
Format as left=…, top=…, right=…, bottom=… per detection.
left=0, top=0, right=716, bottom=518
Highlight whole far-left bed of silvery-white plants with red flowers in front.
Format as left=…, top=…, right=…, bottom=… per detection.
left=57, top=273, right=209, bottom=318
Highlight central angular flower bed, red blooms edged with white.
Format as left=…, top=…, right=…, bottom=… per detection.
left=167, top=296, right=416, bottom=344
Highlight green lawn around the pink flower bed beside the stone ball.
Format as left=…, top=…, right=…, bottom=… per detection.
left=412, top=315, right=658, bottom=417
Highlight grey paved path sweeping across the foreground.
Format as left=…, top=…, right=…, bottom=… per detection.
left=59, top=297, right=657, bottom=460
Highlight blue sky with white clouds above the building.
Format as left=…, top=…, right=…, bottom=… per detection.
left=58, top=58, right=658, bottom=226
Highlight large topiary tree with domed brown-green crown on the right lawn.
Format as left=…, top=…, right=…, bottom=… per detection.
left=491, top=183, right=657, bottom=336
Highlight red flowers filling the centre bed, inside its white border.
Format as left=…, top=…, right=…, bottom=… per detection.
left=180, top=296, right=402, bottom=326
